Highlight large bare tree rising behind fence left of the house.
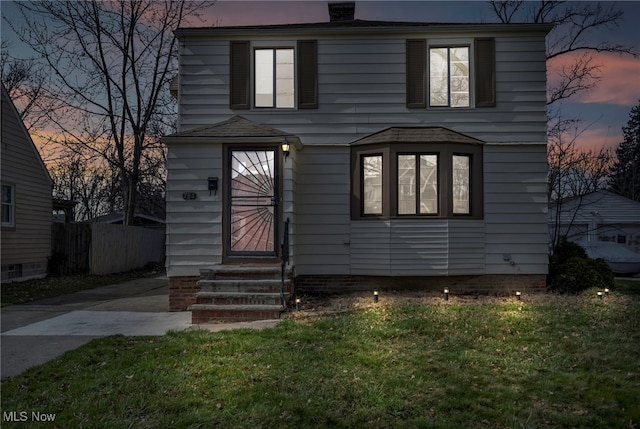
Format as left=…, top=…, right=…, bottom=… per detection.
left=9, top=0, right=212, bottom=224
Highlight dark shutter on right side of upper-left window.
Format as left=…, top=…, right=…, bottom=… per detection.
left=298, top=40, right=318, bottom=109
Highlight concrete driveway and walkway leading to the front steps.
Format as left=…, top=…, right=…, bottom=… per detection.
left=0, top=276, right=278, bottom=379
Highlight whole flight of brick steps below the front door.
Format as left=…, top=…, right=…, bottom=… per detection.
left=188, top=265, right=292, bottom=324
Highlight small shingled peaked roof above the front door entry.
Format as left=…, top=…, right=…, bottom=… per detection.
left=162, top=115, right=302, bottom=147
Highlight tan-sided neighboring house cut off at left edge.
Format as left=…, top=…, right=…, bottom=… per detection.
left=0, top=86, right=53, bottom=283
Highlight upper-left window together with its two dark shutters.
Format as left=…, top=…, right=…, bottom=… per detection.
left=229, top=40, right=318, bottom=110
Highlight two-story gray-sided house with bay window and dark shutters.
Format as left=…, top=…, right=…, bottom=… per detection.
left=163, top=3, right=551, bottom=320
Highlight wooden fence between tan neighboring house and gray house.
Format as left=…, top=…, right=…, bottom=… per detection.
left=49, top=223, right=165, bottom=275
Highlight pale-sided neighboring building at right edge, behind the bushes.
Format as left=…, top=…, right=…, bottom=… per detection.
left=549, top=191, right=640, bottom=253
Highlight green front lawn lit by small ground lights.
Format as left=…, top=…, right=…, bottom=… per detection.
left=2, top=282, right=640, bottom=428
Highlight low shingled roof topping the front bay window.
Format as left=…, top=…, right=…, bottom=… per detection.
left=351, top=126, right=484, bottom=146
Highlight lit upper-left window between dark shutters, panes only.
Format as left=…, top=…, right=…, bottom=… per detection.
left=254, top=48, right=295, bottom=108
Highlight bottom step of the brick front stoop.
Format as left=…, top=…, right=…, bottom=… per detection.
left=189, top=304, right=283, bottom=325
